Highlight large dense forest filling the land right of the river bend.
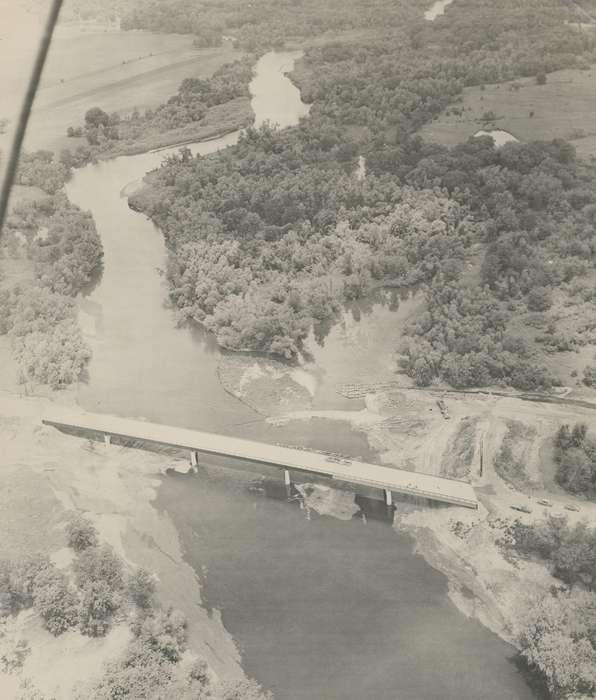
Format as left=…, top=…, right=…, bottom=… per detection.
left=132, top=0, right=596, bottom=389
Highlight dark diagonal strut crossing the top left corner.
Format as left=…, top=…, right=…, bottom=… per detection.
left=0, top=0, right=62, bottom=235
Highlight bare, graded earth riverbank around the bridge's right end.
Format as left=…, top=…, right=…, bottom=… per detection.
left=217, top=359, right=596, bottom=645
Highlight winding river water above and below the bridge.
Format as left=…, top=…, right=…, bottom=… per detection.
left=68, top=53, right=533, bottom=700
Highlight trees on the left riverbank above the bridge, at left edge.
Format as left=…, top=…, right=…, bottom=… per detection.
left=0, top=183, right=103, bottom=389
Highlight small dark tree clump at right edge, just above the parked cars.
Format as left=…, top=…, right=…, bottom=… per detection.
left=555, top=423, right=596, bottom=498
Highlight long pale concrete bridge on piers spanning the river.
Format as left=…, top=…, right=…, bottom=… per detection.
left=42, top=409, right=478, bottom=508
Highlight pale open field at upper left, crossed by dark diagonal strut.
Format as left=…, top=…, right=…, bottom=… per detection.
left=0, top=19, right=242, bottom=150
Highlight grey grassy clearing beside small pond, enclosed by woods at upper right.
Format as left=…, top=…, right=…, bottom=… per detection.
left=420, top=67, right=596, bottom=157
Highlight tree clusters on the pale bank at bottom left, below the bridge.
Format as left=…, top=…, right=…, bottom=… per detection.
left=0, top=514, right=272, bottom=700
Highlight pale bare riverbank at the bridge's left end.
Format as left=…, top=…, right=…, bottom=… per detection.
left=0, top=392, right=249, bottom=699
